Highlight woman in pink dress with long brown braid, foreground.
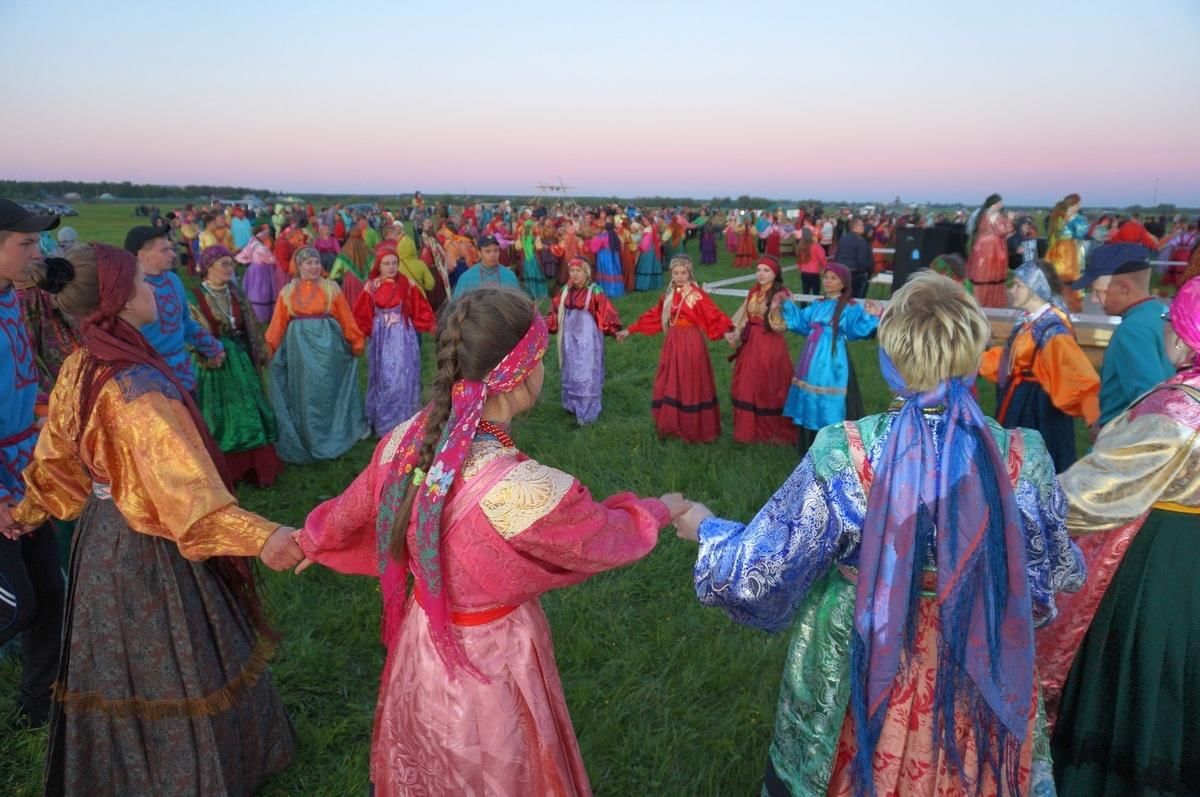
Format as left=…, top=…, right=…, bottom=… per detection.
left=298, top=289, right=685, bottom=797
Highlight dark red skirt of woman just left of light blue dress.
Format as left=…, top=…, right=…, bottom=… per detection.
left=730, top=319, right=796, bottom=445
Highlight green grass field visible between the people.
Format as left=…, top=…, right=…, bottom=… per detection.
left=0, top=205, right=1089, bottom=797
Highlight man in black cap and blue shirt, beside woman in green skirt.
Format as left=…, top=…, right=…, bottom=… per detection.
left=125, top=227, right=224, bottom=390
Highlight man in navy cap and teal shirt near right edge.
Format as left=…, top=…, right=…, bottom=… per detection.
left=1072, top=244, right=1175, bottom=436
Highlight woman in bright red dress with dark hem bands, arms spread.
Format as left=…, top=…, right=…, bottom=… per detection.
left=617, top=253, right=729, bottom=443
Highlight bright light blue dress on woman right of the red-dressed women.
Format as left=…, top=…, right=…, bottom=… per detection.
left=780, top=299, right=880, bottom=430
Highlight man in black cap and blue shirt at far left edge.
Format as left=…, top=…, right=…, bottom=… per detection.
left=0, top=199, right=64, bottom=725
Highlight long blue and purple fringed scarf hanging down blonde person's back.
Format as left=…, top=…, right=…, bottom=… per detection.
left=851, top=347, right=1033, bottom=795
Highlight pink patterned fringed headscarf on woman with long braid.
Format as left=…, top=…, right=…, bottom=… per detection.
left=376, top=311, right=550, bottom=682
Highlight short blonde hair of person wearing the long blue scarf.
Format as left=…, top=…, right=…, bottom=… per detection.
left=878, top=271, right=991, bottom=391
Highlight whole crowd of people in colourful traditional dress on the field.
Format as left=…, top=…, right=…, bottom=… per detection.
left=0, top=196, right=1200, bottom=797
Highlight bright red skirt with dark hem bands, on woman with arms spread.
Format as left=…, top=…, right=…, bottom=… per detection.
left=650, top=325, right=721, bottom=443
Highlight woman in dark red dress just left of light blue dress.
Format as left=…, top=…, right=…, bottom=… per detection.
left=725, top=254, right=796, bottom=445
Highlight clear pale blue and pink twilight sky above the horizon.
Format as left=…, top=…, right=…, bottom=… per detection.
left=0, top=0, right=1200, bottom=208
